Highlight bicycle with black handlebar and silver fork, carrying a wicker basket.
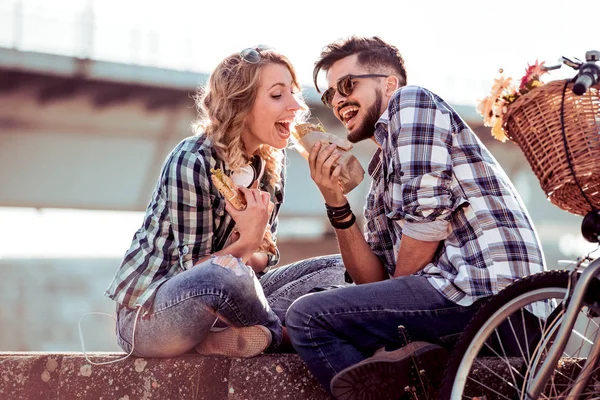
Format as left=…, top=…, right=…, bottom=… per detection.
left=439, top=51, right=600, bottom=400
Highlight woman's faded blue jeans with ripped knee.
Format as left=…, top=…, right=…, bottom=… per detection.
left=117, top=255, right=347, bottom=357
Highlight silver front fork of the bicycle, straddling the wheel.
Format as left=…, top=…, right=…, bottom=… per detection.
left=526, top=259, right=600, bottom=400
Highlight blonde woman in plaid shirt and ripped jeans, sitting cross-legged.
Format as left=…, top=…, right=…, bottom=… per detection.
left=106, top=46, right=344, bottom=357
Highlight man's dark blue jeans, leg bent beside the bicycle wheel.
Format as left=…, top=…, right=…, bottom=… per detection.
left=286, top=275, right=479, bottom=390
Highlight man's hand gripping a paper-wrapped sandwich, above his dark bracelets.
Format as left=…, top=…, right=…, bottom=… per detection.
left=308, top=142, right=348, bottom=207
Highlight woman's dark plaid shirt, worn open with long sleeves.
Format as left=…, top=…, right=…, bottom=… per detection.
left=105, top=135, right=285, bottom=308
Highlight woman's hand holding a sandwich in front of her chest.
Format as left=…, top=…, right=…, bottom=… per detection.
left=225, top=187, right=273, bottom=252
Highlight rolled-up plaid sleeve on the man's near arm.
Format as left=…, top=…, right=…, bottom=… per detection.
left=388, top=86, right=454, bottom=241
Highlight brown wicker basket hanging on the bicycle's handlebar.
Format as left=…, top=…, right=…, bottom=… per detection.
left=504, top=80, right=600, bottom=215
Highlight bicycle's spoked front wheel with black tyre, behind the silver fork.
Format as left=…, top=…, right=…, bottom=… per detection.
left=439, top=271, right=600, bottom=400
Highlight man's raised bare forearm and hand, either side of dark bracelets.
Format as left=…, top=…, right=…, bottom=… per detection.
left=308, top=142, right=388, bottom=284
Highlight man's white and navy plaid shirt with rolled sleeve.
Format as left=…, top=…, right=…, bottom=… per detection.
left=365, top=86, right=545, bottom=306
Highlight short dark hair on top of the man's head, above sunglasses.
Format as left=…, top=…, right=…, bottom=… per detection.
left=313, top=36, right=406, bottom=93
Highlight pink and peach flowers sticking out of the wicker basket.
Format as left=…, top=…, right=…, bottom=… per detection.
left=477, top=60, right=548, bottom=142
